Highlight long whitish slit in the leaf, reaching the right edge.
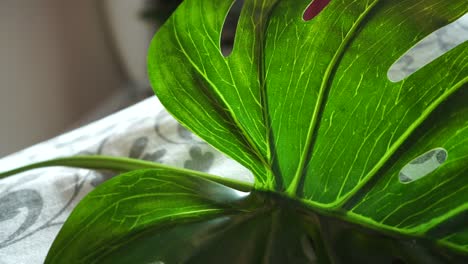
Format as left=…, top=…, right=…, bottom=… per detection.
left=387, top=13, right=468, bottom=82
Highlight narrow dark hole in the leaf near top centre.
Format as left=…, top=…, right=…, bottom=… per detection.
left=220, top=0, right=244, bottom=57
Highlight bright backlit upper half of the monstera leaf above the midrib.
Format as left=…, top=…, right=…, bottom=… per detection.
left=149, top=0, right=468, bottom=252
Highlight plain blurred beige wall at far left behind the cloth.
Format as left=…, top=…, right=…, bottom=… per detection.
left=0, top=0, right=122, bottom=157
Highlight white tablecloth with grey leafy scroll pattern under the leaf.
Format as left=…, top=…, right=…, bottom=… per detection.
left=0, top=13, right=468, bottom=264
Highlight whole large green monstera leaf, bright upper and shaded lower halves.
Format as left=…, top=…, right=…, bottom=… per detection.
left=0, top=0, right=468, bottom=263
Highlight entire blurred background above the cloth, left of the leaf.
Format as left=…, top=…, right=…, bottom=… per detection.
left=0, top=0, right=186, bottom=157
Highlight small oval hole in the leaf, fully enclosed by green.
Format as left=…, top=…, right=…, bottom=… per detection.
left=398, top=148, right=448, bottom=184
